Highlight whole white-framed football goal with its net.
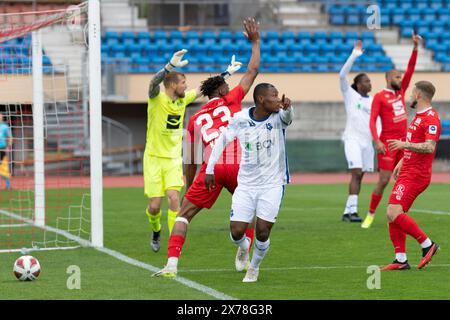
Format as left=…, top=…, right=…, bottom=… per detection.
left=0, top=0, right=103, bottom=252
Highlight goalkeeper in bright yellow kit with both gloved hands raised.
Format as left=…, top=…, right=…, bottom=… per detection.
left=143, top=49, right=244, bottom=252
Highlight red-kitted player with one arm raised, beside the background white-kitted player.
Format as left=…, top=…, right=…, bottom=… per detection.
left=361, top=34, right=421, bottom=229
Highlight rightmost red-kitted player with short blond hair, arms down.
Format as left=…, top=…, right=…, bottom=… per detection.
left=383, top=81, right=441, bottom=270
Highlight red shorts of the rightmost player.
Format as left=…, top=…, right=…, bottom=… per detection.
left=388, top=177, right=430, bottom=212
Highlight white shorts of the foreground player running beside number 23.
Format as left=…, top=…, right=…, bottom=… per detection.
left=230, top=186, right=284, bottom=223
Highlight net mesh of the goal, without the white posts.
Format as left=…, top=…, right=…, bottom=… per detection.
left=0, top=3, right=90, bottom=251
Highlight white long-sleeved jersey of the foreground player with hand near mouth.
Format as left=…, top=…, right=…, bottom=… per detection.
left=206, top=107, right=293, bottom=188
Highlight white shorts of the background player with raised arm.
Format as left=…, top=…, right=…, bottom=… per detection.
left=344, top=139, right=375, bottom=172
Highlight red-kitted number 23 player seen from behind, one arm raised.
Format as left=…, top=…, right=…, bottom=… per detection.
left=154, top=19, right=260, bottom=278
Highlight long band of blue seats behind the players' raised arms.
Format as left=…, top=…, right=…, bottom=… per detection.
left=102, top=30, right=393, bottom=73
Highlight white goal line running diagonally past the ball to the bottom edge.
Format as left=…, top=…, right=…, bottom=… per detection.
left=0, top=210, right=237, bottom=300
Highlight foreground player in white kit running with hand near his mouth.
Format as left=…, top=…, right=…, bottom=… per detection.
left=205, top=83, right=293, bottom=282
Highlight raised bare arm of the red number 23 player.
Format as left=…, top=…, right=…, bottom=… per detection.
left=239, top=18, right=261, bottom=94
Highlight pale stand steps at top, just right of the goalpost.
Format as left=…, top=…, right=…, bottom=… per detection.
left=100, top=0, right=147, bottom=30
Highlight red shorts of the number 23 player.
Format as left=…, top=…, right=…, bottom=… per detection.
left=184, top=163, right=239, bottom=209
